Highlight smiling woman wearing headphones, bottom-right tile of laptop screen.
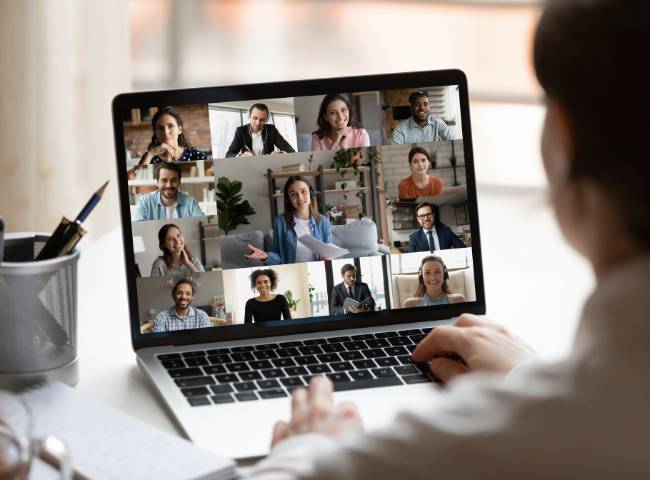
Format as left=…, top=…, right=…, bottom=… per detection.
left=404, top=255, right=466, bottom=308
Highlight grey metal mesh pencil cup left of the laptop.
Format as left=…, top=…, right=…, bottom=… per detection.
left=0, top=233, right=79, bottom=390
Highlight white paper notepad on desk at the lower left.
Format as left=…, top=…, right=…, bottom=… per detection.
left=23, top=383, right=236, bottom=480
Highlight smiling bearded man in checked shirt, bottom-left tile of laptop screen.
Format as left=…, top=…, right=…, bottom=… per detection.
left=153, top=278, right=212, bottom=333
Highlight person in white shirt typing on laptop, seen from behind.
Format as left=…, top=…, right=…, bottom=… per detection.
left=250, top=0, right=650, bottom=480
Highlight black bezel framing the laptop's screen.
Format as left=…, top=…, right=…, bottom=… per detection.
left=112, top=70, right=486, bottom=350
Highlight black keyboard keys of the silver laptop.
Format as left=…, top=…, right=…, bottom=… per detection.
left=157, top=328, right=436, bottom=407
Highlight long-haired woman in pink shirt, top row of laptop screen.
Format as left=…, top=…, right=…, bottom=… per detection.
left=311, top=93, right=370, bottom=150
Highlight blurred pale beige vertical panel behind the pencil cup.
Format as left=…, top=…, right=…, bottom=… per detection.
left=0, top=0, right=131, bottom=242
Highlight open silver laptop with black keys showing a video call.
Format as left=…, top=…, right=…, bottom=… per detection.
left=112, top=70, right=485, bottom=459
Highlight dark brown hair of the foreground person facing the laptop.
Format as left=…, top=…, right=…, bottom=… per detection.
left=533, top=0, right=650, bottom=250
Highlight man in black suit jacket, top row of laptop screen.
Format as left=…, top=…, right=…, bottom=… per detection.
left=226, top=103, right=295, bottom=157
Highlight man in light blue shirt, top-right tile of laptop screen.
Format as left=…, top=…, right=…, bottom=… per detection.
left=392, top=90, right=454, bottom=144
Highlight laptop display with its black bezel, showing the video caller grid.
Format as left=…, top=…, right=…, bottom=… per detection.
left=114, top=72, right=484, bottom=339
